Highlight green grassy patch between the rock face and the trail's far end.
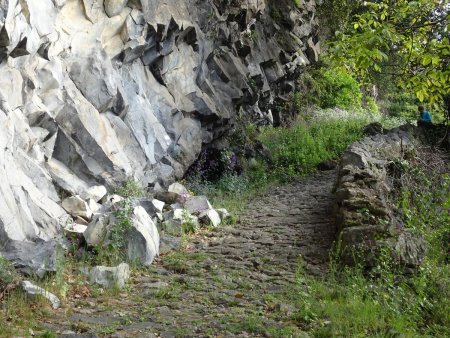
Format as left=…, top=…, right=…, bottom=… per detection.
left=185, top=115, right=369, bottom=217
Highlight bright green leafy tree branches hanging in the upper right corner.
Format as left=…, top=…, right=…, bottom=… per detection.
left=325, top=0, right=450, bottom=115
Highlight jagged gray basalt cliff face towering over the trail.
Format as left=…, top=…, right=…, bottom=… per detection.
left=0, top=0, right=319, bottom=270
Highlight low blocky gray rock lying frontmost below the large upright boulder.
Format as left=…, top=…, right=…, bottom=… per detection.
left=89, top=263, right=130, bottom=289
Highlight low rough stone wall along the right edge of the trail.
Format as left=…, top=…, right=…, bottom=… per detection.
left=336, top=125, right=425, bottom=269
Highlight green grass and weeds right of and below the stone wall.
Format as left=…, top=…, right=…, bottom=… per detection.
left=278, top=158, right=450, bottom=337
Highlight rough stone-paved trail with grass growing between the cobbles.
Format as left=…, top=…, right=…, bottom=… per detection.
left=47, top=171, right=335, bottom=337
